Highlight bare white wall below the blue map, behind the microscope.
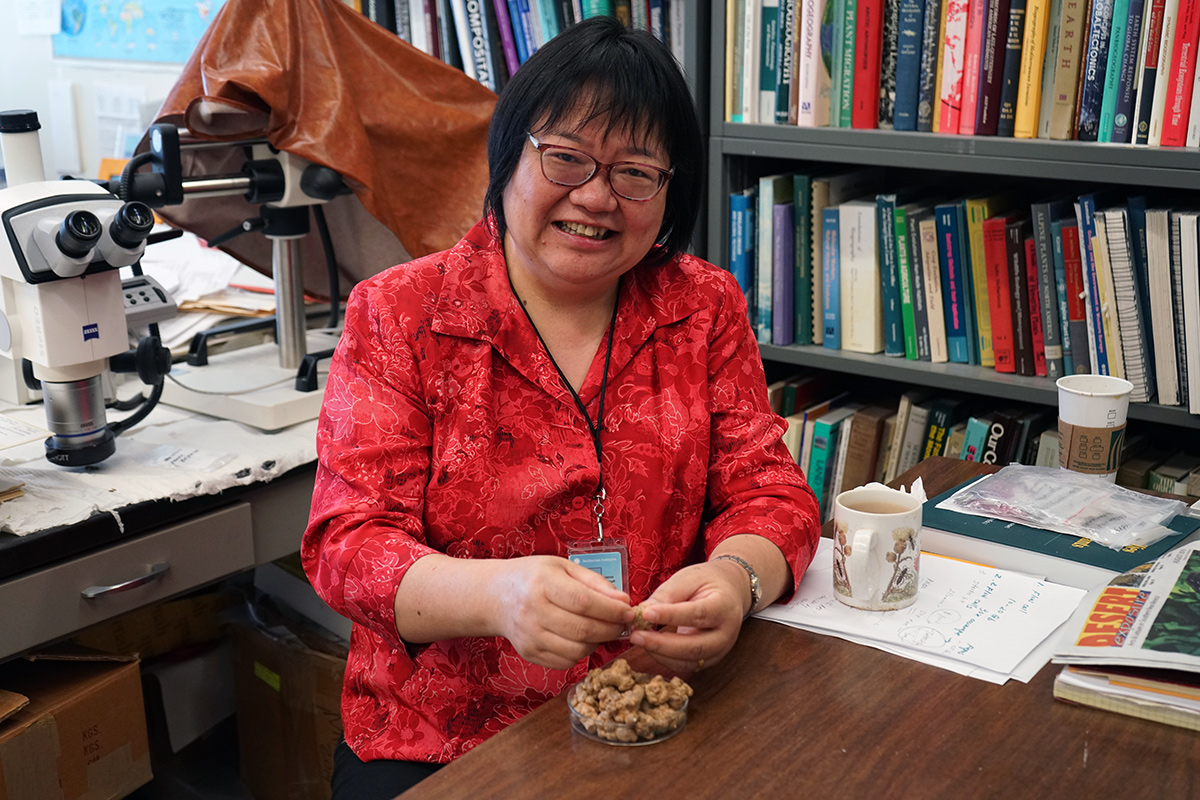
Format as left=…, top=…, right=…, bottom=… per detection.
left=0, top=0, right=182, bottom=179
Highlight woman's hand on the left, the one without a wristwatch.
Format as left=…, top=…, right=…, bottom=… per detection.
left=490, top=555, right=630, bottom=669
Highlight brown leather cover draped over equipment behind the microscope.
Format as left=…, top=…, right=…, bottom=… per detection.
left=138, top=0, right=496, bottom=297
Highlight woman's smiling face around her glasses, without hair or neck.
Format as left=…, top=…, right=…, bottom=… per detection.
left=503, top=110, right=671, bottom=299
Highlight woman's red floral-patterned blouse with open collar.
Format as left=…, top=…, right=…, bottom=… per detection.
left=301, top=223, right=818, bottom=763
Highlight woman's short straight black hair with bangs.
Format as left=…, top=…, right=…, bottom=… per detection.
left=484, top=17, right=704, bottom=260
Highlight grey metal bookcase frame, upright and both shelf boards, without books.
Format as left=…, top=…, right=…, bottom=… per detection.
left=704, top=4, right=1200, bottom=437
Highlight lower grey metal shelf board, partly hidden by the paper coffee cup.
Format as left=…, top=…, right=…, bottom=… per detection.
left=758, top=344, right=1200, bottom=431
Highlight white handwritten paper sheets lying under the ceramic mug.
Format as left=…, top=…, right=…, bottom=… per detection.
left=755, top=539, right=1085, bottom=684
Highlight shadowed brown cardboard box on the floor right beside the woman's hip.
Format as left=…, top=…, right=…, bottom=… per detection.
left=230, top=624, right=346, bottom=800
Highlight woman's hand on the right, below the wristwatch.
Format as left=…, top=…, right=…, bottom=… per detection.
left=629, top=561, right=748, bottom=673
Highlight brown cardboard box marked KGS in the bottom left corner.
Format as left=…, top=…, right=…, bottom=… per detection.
left=0, top=656, right=151, bottom=800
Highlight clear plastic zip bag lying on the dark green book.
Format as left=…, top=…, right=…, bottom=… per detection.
left=937, top=464, right=1187, bottom=549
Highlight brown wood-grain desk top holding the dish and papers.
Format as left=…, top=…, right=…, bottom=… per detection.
left=404, top=458, right=1200, bottom=800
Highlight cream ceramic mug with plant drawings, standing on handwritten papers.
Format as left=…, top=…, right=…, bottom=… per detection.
left=833, top=483, right=924, bottom=610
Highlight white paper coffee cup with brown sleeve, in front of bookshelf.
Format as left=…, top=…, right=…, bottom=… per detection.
left=1056, top=375, right=1133, bottom=482
